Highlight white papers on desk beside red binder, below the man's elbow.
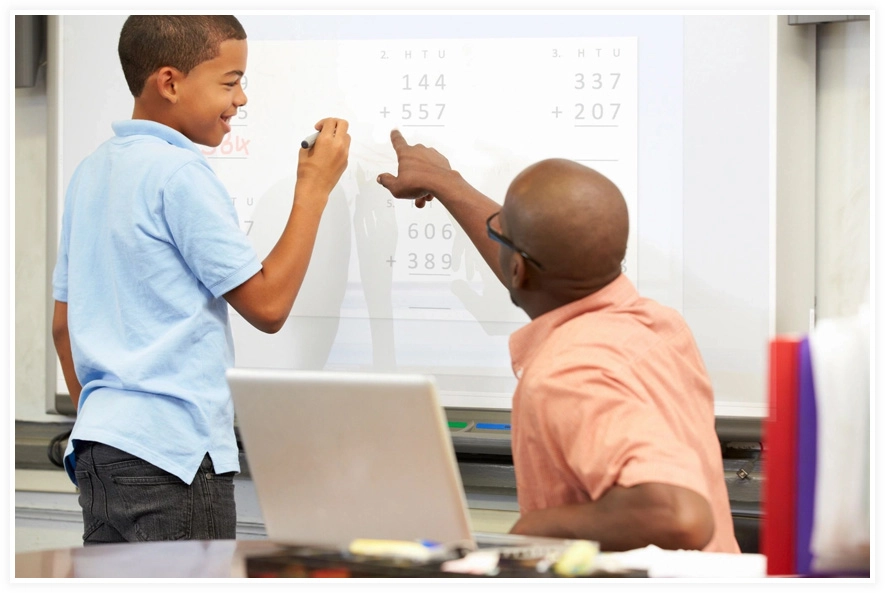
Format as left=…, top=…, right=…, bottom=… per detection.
left=595, top=545, right=766, bottom=579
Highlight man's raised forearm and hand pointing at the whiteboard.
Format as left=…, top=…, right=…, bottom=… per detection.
left=378, top=130, right=501, bottom=280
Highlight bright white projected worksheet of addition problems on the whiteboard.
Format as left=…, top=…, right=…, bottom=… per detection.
left=212, top=38, right=637, bottom=322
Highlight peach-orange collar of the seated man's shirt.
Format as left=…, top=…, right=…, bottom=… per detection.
left=510, top=274, right=639, bottom=378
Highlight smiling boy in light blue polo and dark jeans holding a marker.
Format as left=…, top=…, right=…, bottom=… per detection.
left=52, top=15, right=350, bottom=545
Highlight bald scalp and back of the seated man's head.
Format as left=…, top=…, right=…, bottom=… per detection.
left=501, top=159, right=629, bottom=293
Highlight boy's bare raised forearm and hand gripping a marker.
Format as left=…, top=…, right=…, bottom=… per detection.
left=224, top=119, right=350, bottom=333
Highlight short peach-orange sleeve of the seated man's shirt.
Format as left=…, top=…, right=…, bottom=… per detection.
left=539, top=368, right=708, bottom=500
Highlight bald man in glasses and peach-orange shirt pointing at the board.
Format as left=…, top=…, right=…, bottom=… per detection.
left=378, top=130, right=740, bottom=552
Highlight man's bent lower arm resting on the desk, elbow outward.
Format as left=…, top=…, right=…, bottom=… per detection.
left=510, top=483, right=714, bottom=551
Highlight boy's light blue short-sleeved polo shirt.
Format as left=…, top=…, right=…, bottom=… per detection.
left=53, top=120, right=261, bottom=484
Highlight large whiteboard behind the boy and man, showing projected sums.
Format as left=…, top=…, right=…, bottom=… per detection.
left=51, top=13, right=774, bottom=416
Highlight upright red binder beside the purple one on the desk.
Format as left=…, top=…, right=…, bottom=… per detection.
left=759, top=336, right=800, bottom=575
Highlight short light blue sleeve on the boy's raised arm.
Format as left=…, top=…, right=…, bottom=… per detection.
left=163, top=161, right=261, bottom=298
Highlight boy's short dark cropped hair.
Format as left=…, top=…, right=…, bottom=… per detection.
left=117, top=15, right=246, bottom=97
